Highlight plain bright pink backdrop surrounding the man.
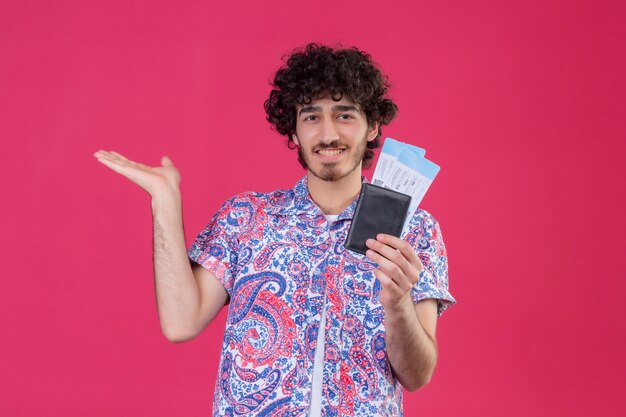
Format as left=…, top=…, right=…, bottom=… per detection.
left=0, top=0, right=626, bottom=416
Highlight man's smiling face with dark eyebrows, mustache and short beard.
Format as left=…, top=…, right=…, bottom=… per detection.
left=294, top=97, right=378, bottom=181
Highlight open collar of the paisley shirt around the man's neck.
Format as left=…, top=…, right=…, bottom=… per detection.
left=266, top=175, right=368, bottom=220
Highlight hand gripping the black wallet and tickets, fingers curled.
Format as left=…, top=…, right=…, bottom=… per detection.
left=365, top=233, right=424, bottom=310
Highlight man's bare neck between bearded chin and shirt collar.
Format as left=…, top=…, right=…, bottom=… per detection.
left=307, top=167, right=361, bottom=214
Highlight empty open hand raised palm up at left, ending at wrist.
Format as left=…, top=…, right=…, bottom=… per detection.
left=94, top=150, right=180, bottom=197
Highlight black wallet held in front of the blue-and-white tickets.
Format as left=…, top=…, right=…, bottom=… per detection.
left=345, top=183, right=411, bottom=255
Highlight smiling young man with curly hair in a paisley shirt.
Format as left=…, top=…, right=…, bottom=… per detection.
left=96, top=44, right=454, bottom=416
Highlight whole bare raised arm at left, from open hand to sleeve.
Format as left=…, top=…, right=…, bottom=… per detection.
left=94, top=151, right=228, bottom=342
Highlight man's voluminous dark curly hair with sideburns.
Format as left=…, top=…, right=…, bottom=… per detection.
left=264, top=43, right=398, bottom=168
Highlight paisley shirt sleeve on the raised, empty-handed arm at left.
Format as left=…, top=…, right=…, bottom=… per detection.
left=187, top=197, right=239, bottom=297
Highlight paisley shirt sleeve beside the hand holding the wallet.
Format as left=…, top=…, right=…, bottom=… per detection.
left=407, top=210, right=456, bottom=316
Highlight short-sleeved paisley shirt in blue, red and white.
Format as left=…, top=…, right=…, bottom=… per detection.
left=188, top=177, right=455, bottom=416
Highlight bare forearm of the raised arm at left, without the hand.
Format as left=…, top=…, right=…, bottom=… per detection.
left=152, top=192, right=200, bottom=341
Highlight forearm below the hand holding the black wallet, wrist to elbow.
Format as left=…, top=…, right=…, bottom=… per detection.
left=385, top=298, right=437, bottom=391
